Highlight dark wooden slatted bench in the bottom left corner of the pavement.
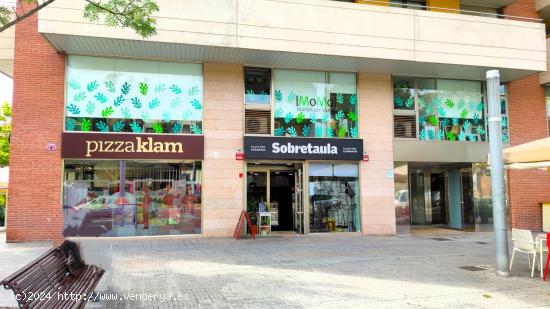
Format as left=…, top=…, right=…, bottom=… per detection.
left=0, top=241, right=105, bottom=309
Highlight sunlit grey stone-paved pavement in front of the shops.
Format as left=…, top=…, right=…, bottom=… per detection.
left=0, top=231, right=550, bottom=308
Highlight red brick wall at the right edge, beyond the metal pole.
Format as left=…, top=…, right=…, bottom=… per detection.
left=504, top=0, right=550, bottom=230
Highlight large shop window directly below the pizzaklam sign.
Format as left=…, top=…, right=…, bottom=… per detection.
left=63, top=160, right=202, bottom=237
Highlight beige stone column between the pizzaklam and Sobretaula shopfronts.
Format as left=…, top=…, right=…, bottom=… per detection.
left=202, top=63, right=245, bottom=237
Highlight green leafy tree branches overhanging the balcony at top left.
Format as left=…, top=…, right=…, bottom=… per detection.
left=0, top=0, right=159, bottom=38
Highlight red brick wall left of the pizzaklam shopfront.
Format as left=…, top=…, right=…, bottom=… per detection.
left=6, top=3, right=65, bottom=242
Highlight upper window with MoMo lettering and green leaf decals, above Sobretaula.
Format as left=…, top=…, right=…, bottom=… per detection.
left=274, top=70, right=359, bottom=138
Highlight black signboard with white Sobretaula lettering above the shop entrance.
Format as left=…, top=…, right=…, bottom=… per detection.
left=244, top=136, right=363, bottom=161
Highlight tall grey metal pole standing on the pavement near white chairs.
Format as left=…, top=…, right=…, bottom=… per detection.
left=486, top=70, right=509, bottom=277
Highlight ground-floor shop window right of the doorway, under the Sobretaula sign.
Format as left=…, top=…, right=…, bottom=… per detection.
left=309, top=163, right=360, bottom=233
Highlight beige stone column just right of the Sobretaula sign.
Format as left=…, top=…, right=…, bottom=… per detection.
left=358, top=73, right=396, bottom=235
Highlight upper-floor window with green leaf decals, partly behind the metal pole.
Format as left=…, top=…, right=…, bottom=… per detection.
left=393, top=77, right=494, bottom=142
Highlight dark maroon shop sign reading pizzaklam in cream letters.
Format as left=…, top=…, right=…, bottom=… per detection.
left=61, top=133, right=204, bottom=160
